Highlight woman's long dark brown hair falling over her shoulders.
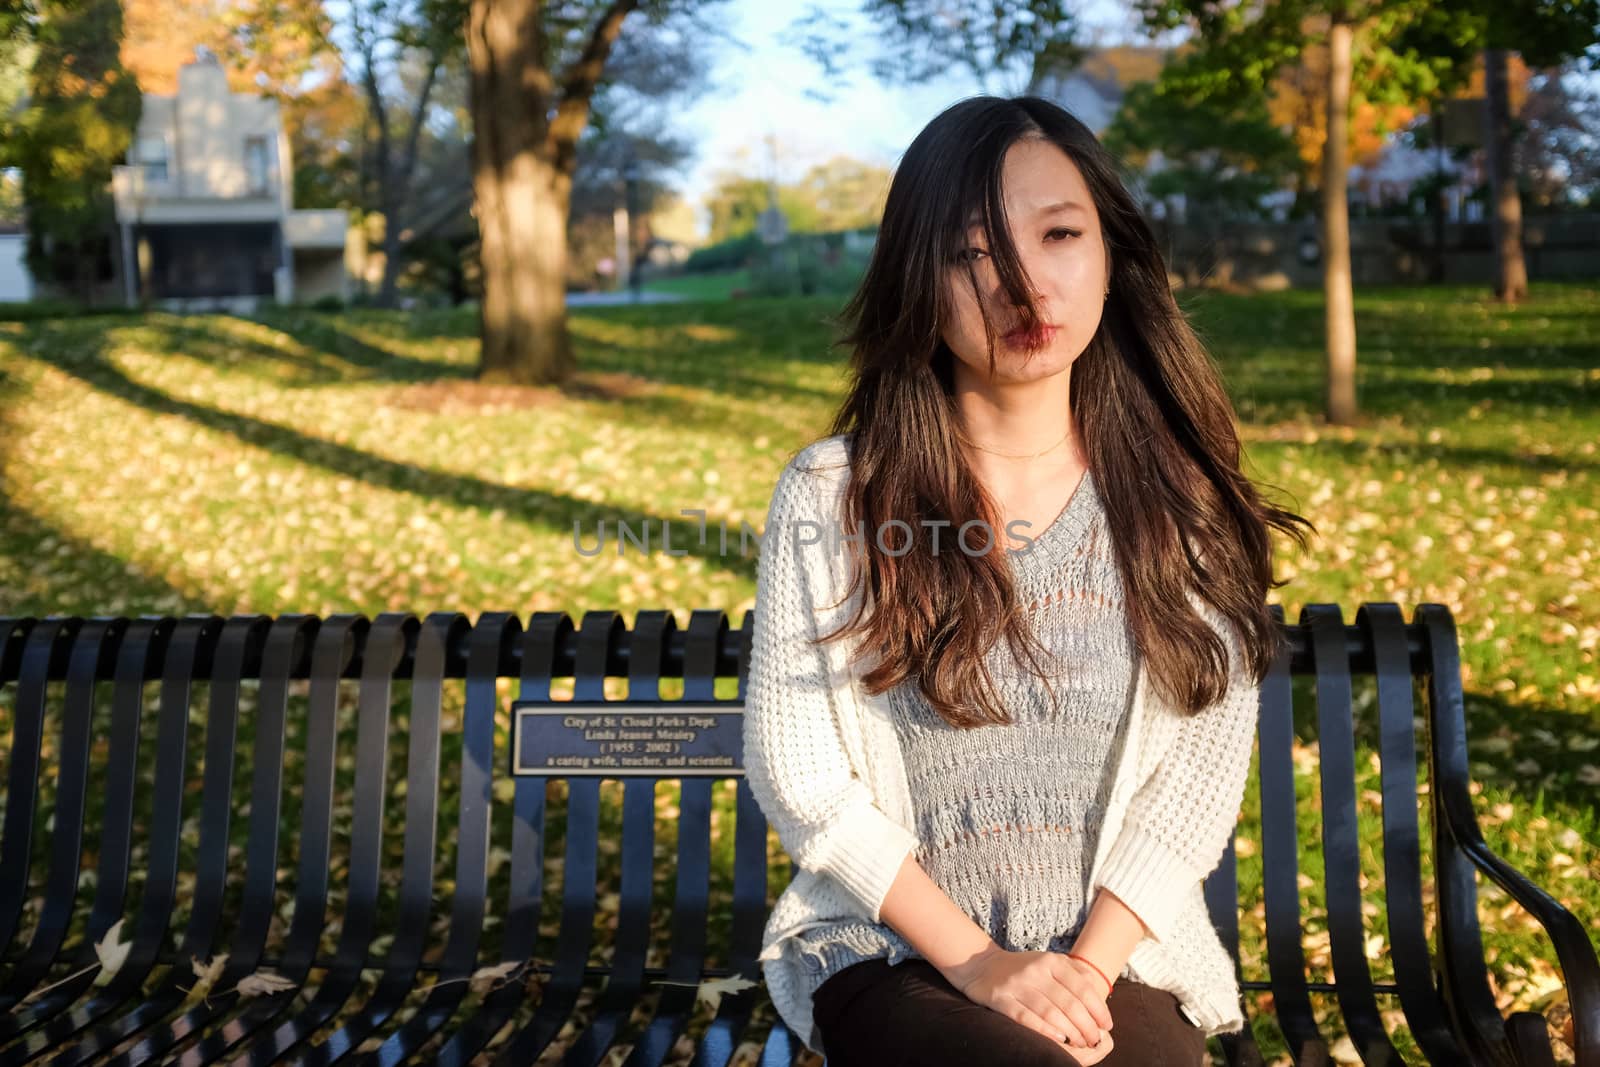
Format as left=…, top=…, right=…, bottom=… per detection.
left=800, top=96, right=1312, bottom=728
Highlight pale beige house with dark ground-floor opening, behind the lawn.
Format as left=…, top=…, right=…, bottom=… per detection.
left=112, top=53, right=350, bottom=310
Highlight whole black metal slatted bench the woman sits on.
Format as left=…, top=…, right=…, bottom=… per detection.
left=0, top=605, right=1600, bottom=1065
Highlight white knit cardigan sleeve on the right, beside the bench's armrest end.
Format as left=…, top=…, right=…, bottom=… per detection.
left=1091, top=603, right=1261, bottom=941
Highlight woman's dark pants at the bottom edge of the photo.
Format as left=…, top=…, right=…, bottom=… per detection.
left=813, top=958, right=1206, bottom=1067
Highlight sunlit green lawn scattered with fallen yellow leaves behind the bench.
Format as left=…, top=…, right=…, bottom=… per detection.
left=0, top=285, right=1600, bottom=1048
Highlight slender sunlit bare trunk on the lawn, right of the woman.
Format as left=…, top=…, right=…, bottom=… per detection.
left=1322, top=18, right=1355, bottom=426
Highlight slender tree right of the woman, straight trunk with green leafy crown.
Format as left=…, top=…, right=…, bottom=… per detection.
left=1141, top=0, right=1448, bottom=424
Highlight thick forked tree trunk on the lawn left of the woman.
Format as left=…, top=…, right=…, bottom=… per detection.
left=461, top=0, right=732, bottom=384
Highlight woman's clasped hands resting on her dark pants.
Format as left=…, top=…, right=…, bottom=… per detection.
left=946, top=945, right=1112, bottom=1064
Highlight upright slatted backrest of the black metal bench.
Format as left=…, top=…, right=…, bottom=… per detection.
left=0, top=603, right=1548, bottom=1062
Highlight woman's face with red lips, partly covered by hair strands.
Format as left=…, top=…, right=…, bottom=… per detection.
left=941, top=139, right=1110, bottom=384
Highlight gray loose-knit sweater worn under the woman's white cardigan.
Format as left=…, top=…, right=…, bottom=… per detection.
left=784, top=474, right=1134, bottom=993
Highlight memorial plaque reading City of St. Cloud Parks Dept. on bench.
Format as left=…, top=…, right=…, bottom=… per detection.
left=510, top=701, right=744, bottom=777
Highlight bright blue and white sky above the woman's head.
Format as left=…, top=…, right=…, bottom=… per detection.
left=675, top=0, right=1133, bottom=232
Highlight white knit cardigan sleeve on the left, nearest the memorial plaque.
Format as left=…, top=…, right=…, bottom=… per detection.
left=744, top=462, right=917, bottom=923
